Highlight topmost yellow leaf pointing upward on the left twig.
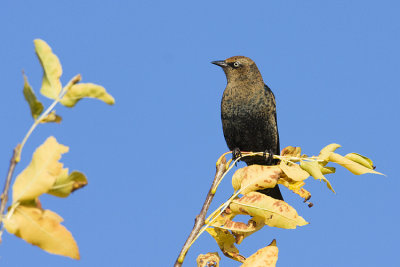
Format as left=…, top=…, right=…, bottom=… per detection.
left=34, top=39, right=62, bottom=99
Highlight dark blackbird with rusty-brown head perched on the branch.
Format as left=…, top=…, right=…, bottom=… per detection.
left=211, top=56, right=283, bottom=200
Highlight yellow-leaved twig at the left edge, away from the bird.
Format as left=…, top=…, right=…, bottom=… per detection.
left=0, top=39, right=115, bottom=259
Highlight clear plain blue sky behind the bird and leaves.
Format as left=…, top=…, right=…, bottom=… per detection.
left=0, top=0, right=400, bottom=267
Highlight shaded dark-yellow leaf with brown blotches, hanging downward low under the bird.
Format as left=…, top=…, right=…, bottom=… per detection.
left=206, top=228, right=246, bottom=262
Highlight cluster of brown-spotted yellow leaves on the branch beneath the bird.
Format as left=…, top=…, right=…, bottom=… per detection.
left=199, top=144, right=382, bottom=267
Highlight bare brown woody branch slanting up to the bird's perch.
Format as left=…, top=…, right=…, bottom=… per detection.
left=174, top=155, right=227, bottom=267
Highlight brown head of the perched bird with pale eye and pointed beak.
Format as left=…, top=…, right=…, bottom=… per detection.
left=211, top=56, right=262, bottom=83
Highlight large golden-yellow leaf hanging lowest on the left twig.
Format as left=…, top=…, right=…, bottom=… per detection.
left=4, top=205, right=79, bottom=259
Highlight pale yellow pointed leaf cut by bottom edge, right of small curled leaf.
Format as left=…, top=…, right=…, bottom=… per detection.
left=241, top=239, right=279, bottom=267
